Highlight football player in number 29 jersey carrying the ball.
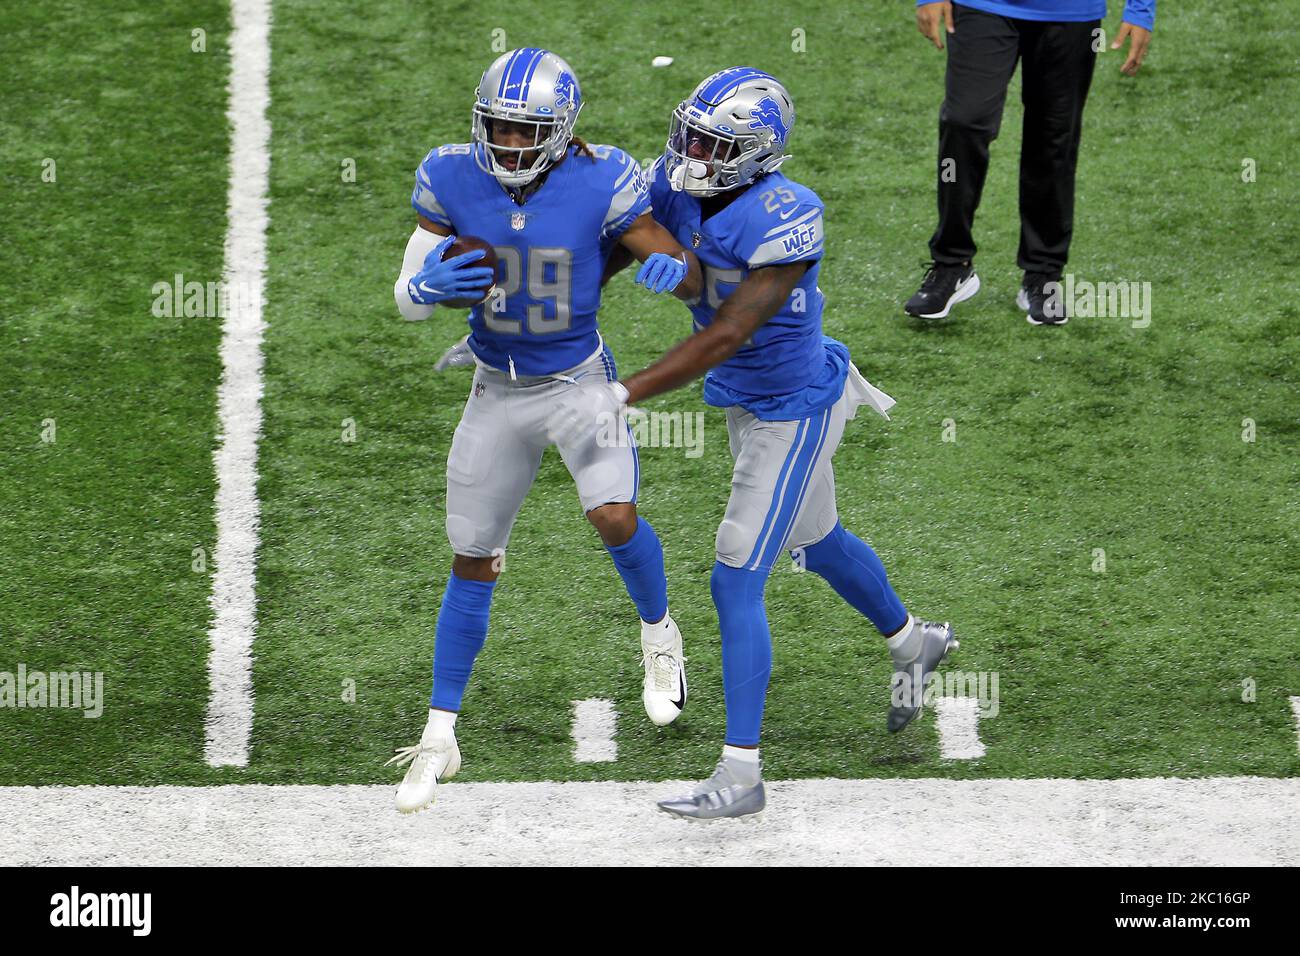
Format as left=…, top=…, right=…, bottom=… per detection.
left=390, top=47, right=701, bottom=813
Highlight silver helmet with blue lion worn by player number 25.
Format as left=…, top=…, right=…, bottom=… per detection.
left=664, top=66, right=794, bottom=196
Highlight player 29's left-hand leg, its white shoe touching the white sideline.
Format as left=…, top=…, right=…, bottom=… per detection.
left=395, top=369, right=545, bottom=813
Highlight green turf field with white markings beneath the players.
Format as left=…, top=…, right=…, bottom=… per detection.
left=0, top=0, right=1300, bottom=784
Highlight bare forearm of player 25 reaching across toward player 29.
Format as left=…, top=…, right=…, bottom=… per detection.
left=623, top=261, right=811, bottom=405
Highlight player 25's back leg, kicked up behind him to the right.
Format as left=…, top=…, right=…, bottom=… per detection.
left=788, top=397, right=957, bottom=731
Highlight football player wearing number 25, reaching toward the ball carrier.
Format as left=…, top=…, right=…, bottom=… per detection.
left=555, top=66, right=957, bottom=818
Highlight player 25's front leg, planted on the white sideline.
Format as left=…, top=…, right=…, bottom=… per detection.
left=659, top=408, right=842, bottom=818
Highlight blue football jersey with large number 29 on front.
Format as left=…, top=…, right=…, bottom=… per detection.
left=411, top=143, right=650, bottom=375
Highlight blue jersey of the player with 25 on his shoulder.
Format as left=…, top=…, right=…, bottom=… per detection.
left=650, top=159, right=849, bottom=421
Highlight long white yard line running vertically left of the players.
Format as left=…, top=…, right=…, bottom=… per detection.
left=203, top=0, right=270, bottom=766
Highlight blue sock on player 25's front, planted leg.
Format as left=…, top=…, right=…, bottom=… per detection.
left=709, top=561, right=772, bottom=747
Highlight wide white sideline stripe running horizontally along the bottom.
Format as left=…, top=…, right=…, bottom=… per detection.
left=0, top=767, right=1300, bottom=868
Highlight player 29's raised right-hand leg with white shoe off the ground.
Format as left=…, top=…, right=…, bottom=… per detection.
left=551, top=352, right=686, bottom=726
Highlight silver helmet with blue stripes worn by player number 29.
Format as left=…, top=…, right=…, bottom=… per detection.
left=471, top=47, right=582, bottom=186
